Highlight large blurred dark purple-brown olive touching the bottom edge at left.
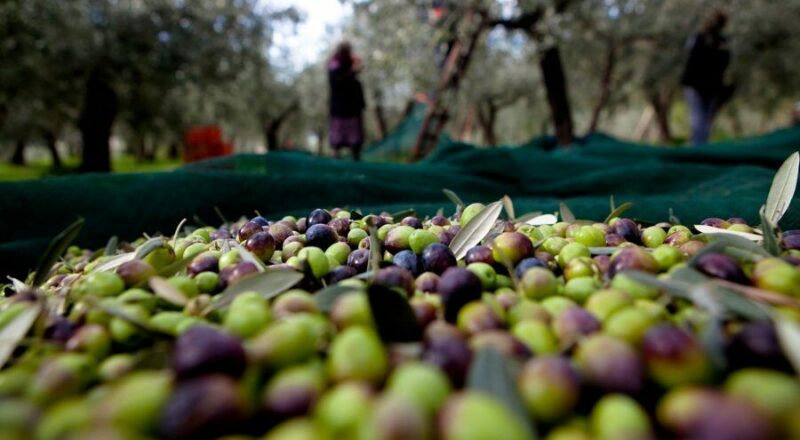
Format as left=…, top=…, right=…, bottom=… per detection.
left=161, top=375, right=247, bottom=440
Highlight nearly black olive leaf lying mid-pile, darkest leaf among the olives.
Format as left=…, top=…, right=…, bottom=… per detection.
left=367, top=284, right=422, bottom=342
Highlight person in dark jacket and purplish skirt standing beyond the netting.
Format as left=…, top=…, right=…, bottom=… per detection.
left=328, top=41, right=366, bottom=160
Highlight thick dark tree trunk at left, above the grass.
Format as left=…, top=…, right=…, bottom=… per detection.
left=80, top=70, right=117, bottom=172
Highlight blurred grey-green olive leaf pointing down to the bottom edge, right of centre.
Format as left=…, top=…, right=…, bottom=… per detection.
left=467, top=348, right=537, bottom=439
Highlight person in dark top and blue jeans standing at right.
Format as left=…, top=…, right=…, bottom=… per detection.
left=681, top=9, right=733, bottom=144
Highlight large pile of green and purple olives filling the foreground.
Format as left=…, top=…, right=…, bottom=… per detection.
left=0, top=204, right=800, bottom=440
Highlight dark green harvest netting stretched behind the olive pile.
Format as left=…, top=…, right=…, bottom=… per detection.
left=0, top=124, right=800, bottom=276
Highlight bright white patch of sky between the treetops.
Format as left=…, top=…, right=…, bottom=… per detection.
left=268, top=0, right=352, bottom=71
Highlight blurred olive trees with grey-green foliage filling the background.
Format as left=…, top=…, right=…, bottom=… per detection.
left=0, top=0, right=800, bottom=174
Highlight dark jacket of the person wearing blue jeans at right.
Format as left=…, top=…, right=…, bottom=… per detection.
left=681, top=33, right=731, bottom=97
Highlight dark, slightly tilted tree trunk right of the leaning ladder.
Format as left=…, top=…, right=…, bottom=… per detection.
left=539, top=46, right=575, bottom=145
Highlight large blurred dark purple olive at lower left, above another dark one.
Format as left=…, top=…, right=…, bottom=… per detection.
left=171, top=326, right=246, bottom=380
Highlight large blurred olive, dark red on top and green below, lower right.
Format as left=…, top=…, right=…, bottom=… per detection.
left=642, top=324, right=712, bottom=388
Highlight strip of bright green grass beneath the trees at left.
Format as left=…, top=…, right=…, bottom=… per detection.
left=0, top=156, right=181, bottom=181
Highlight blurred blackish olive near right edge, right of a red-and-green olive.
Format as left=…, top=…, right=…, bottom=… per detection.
left=725, top=321, right=791, bottom=371
